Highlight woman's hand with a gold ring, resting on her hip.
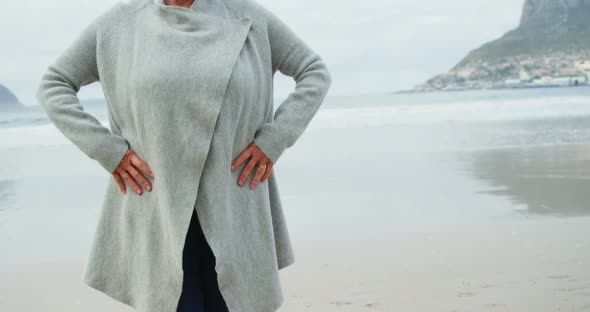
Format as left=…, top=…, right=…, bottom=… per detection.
left=231, top=142, right=273, bottom=189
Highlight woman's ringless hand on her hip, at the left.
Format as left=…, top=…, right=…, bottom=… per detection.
left=113, top=149, right=154, bottom=195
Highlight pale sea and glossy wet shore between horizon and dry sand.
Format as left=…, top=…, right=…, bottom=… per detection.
left=0, top=87, right=590, bottom=264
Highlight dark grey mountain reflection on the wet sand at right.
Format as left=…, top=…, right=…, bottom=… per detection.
left=468, top=144, right=590, bottom=216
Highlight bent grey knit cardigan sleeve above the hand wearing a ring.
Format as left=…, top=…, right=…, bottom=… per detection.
left=254, top=9, right=331, bottom=163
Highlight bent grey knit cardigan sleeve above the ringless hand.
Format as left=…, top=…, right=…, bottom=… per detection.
left=36, top=20, right=129, bottom=173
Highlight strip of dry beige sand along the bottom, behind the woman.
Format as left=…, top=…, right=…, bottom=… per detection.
left=0, top=217, right=590, bottom=312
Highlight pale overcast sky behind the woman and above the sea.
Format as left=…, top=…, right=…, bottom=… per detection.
left=0, top=0, right=523, bottom=105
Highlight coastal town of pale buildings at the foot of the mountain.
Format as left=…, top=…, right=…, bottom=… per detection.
left=410, top=51, right=590, bottom=92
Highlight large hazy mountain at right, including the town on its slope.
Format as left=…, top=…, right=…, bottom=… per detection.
left=413, top=0, right=590, bottom=91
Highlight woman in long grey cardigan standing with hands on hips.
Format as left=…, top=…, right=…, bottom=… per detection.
left=36, top=0, right=331, bottom=312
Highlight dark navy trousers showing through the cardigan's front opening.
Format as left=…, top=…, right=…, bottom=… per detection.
left=176, top=209, right=229, bottom=312
